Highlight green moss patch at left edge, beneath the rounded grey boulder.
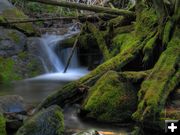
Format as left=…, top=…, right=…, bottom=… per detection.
left=0, top=57, right=20, bottom=84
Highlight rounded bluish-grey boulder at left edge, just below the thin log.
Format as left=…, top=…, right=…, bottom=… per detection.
left=0, top=27, right=27, bottom=57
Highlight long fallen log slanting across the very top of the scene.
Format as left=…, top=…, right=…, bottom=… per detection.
left=29, top=0, right=135, bottom=17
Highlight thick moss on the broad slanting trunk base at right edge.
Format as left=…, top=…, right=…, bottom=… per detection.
left=133, top=29, right=180, bottom=121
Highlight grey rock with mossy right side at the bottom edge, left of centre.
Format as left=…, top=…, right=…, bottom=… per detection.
left=16, top=106, right=64, bottom=135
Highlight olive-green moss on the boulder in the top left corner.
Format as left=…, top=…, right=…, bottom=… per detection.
left=0, top=8, right=35, bottom=35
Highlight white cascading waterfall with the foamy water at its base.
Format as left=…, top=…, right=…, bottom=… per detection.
left=28, top=27, right=88, bottom=81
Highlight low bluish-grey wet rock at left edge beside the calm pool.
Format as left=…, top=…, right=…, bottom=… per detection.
left=0, top=95, right=26, bottom=113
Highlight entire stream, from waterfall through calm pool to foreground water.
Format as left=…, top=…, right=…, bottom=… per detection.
left=0, top=28, right=129, bottom=135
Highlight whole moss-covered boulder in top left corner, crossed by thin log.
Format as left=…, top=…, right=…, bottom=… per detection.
left=0, top=0, right=35, bottom=35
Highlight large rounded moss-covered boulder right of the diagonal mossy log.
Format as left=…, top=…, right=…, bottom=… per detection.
left=82, top=71, right=137, bottom=122
